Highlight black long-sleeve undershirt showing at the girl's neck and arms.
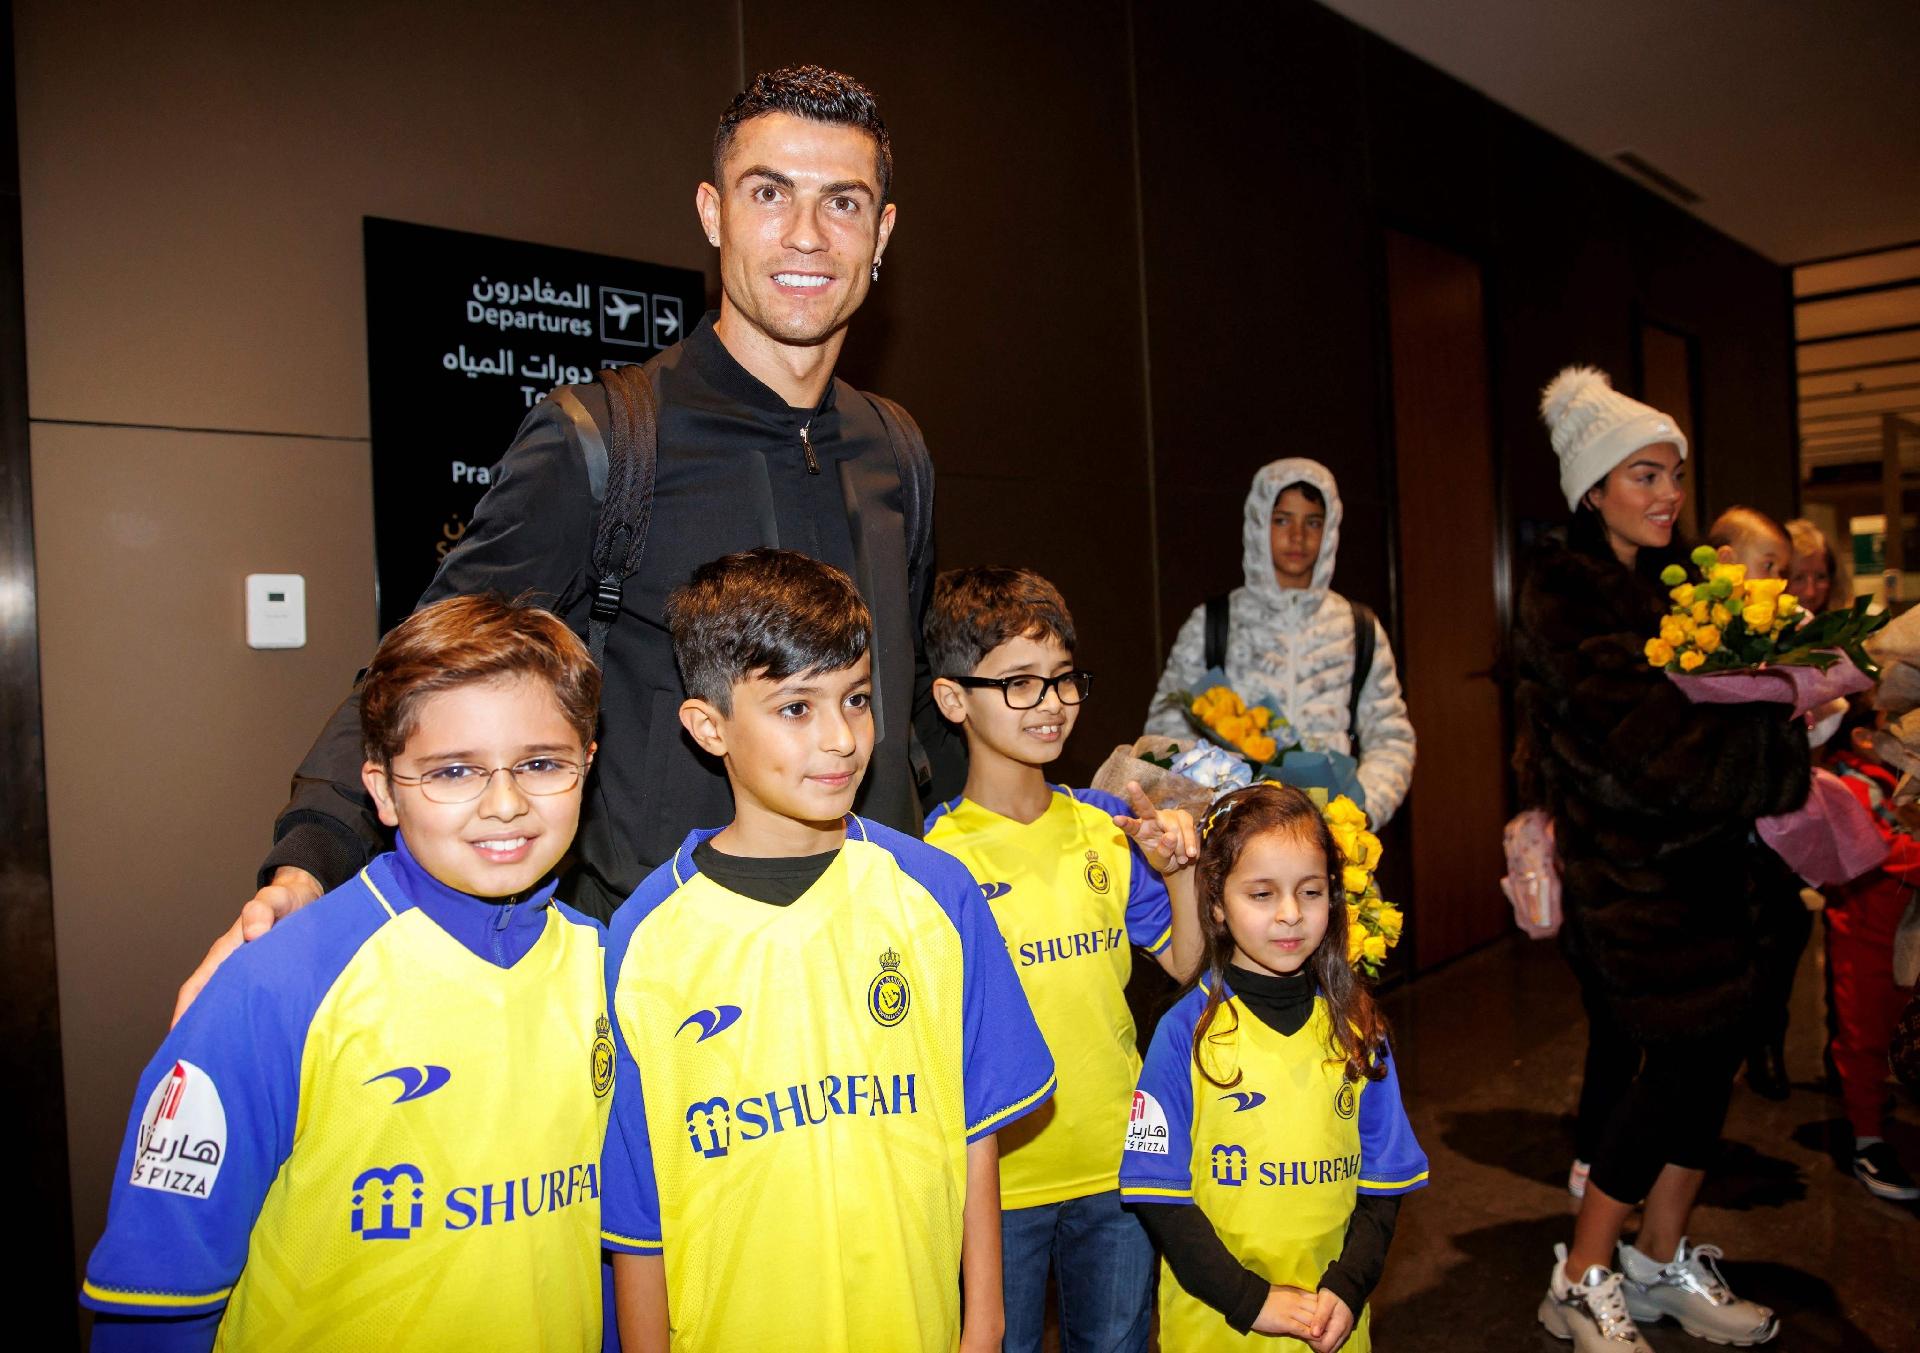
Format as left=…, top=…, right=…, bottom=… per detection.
left=1135, top=965, right=1400, bottom=1334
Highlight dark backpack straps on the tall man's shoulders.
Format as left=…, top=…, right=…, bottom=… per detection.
left=588, top=365, right=933, bottom=666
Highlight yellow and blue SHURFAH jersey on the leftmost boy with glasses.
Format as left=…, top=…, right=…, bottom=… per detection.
left=83, top=840, right=612, bottom=1351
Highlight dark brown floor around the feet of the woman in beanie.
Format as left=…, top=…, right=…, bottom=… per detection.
left=1373, top=929, right=1920, bottom=1353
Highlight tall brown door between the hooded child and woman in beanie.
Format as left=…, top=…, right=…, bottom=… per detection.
left=1386, top=230, right=1511, bottom=967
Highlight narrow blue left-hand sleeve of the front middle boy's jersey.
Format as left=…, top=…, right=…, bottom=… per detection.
left=601, top=866, right=676, bottom=1255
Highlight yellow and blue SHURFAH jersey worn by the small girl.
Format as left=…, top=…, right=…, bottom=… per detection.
left=1119, top=988, right=1427, bottom=1353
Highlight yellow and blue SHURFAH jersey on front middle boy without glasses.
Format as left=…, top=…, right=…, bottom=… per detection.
left=603, top=818, right=1054, bottom=1351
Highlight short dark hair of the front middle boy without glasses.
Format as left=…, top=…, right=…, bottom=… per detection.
left=666, top=547, right=874, bottom=714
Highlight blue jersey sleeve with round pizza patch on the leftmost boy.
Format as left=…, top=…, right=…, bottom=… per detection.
left=81, top=881, right=384, bottom=1320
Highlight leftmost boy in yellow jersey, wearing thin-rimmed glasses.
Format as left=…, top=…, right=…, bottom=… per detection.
left=81, top=597, right=612, bottom=1353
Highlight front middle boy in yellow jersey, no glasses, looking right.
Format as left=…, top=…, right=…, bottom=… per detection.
left=601, top=549, right=1054, bottom=1353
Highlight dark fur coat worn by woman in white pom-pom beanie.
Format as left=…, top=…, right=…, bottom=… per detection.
left=1515, top=541, right=1809, bottom=1042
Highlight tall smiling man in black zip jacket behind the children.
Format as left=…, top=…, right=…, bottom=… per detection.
left=180, top=67, right=948, bottom=1009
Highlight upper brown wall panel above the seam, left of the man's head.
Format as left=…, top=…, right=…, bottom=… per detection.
left=13, top=0, right=737, bottom=433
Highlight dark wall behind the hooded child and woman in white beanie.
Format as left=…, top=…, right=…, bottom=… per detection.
left=1133, top=0, right=1797, bottom=671
